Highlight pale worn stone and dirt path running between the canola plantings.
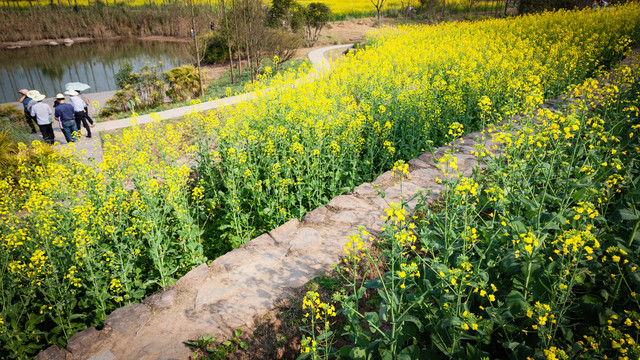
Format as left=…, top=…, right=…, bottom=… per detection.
left=38, top=116, right=510, bottom=360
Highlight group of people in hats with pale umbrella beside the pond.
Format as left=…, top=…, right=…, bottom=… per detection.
left=18, top=89, right=96, bottom=144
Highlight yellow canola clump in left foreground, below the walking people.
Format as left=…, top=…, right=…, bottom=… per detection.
left=0, top=119, right=206, bottom=358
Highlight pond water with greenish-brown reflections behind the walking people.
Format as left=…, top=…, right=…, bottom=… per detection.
left=0, top=40, right=195, bottom=103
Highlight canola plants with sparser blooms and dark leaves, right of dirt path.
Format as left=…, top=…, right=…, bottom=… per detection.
left=312, top=43, right=640, bottom=360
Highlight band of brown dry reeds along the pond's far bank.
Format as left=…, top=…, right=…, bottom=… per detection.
left=0, top=2, right=214, bottom=42
